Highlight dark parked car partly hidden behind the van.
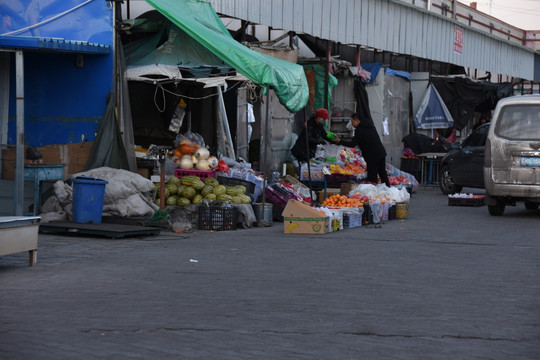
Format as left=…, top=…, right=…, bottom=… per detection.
left=439, top=123, right=490, bottom=194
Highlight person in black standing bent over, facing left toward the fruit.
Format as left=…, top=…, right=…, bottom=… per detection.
left=336, top=113, right=390, bottom=186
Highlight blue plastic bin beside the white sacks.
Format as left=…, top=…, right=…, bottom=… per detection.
left=73, top=177, right=109, bottom=224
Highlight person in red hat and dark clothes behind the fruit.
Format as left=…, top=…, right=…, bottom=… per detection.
left=291, top=108, right=333, bottom=162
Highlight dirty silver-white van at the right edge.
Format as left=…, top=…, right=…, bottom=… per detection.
left=484, top=95, right=540, bottom=216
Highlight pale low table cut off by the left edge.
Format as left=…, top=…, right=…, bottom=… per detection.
left=0, top=216, right=41, bottom=266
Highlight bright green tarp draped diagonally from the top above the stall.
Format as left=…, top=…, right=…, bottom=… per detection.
left=146, top=0, right=309, bottom=113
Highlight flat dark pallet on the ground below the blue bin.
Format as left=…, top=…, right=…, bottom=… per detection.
left=39, top=221, right=161, bottom=239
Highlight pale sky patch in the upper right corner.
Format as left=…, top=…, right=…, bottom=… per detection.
left=472, top=0, right=540, bottom=30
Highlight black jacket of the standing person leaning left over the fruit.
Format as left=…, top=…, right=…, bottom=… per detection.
left=339, top=120, right=386, bottom=161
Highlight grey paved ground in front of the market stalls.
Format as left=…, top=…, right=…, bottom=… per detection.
left=0, top=188, right=540, bottom=360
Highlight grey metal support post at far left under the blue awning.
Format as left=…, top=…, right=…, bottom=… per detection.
left=14, top=50, right=24, bottom=216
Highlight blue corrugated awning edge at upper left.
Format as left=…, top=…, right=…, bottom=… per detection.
left=0, top=36, right=111, bottom=55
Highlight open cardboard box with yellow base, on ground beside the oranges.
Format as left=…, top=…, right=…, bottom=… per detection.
left=282, top=200, right=330, bottom=234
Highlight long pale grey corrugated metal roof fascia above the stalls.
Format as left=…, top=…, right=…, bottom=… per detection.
left=208, top=0, right=535, bottom=79
